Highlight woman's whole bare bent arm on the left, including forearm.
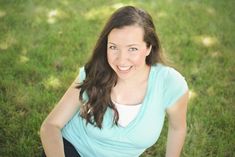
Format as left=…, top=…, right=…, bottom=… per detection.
left=40, top=77, right=81, bottom=157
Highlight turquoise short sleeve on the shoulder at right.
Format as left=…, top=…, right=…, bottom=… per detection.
left=163, top=68, right=188, bottom=108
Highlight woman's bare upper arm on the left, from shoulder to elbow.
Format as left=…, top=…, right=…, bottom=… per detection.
left=43, top=74, right=81, bottom=129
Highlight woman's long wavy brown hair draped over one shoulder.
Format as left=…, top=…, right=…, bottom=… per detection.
left=77, top=6, right=164, bottom=128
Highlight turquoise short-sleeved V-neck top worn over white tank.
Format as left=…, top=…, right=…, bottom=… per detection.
left=62, top=64, right=188, bottom=157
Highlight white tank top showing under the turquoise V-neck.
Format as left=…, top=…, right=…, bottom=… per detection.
left=113, top=102, right=142, bottom=127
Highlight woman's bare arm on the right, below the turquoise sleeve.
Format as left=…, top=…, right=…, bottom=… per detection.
left=166, top=91, right=189, bottom=157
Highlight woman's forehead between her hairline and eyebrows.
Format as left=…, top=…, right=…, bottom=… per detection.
left=108, top=25, right=144, bottom=45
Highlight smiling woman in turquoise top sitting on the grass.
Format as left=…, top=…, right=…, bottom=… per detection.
left=40, top=6, right=188, bottom=157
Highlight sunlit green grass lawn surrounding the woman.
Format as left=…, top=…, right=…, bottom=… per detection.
left=0, top=0, right=235, bottom=157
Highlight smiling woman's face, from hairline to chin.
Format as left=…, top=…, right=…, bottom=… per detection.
left=107, top=25, right=151, bottom=79
